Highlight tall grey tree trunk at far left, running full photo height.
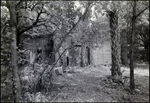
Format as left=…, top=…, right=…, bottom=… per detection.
left=6, top=1, right=21, bottom=102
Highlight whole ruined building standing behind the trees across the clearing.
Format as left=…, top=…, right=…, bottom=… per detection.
left=22, top=30, right=111, bottom=67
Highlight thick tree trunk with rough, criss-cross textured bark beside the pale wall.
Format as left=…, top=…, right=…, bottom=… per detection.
left=108, top=10, right=122, bottom=76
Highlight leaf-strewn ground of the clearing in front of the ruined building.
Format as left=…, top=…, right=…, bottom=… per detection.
left=20, top=63, right=149, bottom=102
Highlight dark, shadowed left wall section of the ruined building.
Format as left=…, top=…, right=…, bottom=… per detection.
left=23, top=37, right=54, bottom=63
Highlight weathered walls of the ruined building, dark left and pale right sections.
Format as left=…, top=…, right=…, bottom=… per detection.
left=23, top=33, right=111, bottom=66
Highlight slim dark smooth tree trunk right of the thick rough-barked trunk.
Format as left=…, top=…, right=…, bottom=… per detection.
left=130, top=1, right=136, bottom=90
